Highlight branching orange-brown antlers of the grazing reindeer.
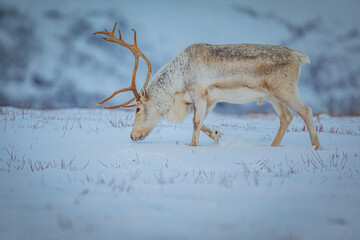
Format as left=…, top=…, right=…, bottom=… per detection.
left=93, top=23, right=151, bottom=109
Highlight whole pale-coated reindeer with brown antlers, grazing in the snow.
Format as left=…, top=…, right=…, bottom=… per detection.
left=94, top=23, right=322, bottom=149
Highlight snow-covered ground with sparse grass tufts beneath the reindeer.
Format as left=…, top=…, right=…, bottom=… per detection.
left=0, top=107, right=360, bottom=239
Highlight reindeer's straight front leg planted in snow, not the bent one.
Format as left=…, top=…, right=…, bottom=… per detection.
left=190, top=94, right=207, bottom=146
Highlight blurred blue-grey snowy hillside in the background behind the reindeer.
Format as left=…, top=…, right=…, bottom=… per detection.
left=0, top=0, right=360, bottom=114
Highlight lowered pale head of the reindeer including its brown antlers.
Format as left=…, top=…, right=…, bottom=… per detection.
left=94, top=23, right=161, bottom=141
